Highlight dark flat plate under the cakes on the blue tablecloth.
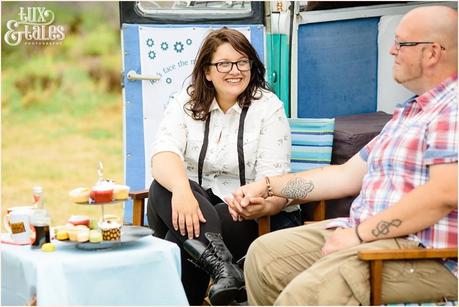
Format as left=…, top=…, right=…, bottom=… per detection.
left=61, top=226, right=153, bottom=250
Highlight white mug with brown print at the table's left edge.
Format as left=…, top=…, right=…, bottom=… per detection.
left=3, top=208, right=33, bottom=244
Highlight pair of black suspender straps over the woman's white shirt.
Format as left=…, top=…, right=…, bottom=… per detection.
left=198, top=107, right=249, bottom=185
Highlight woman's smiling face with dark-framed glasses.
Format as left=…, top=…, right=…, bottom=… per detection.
left=206, top=43, right=250, bottom=102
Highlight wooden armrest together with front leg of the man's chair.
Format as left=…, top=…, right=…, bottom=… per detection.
left=358, top=248, right=457, bottom=305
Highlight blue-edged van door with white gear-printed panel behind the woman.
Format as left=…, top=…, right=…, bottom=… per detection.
left=120, top=1, right=265, bottom=223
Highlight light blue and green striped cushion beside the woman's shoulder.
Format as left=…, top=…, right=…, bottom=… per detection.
left=289, top=118, right=335, bottom=173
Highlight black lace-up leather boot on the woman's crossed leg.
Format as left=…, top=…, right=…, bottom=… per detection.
left=183, top=232, right=247, bottom=305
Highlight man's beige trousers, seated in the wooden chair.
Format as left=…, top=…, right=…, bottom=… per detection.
left=244, top=221, right=458, bottom=305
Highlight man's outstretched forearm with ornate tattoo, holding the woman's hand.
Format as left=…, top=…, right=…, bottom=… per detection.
left=233, top=154, right=367, bottom=206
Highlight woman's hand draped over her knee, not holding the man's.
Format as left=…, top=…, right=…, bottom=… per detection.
left=172, top=190, right=206, bottom=239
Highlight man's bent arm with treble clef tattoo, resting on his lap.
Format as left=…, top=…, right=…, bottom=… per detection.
left=322, top=163, right=458, bottom=254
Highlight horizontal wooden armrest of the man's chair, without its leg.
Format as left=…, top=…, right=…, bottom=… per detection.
left=358, top=248, right=457, bottom=261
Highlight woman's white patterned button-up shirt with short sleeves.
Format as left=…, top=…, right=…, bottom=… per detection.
left=152, top=90, right=291, bottom=207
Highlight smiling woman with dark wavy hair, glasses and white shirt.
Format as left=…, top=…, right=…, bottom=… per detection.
left=147, top=28, right=300, bottom=305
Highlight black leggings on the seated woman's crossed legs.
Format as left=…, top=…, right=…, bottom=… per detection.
left=147, top=180, right=301, bottom=305
